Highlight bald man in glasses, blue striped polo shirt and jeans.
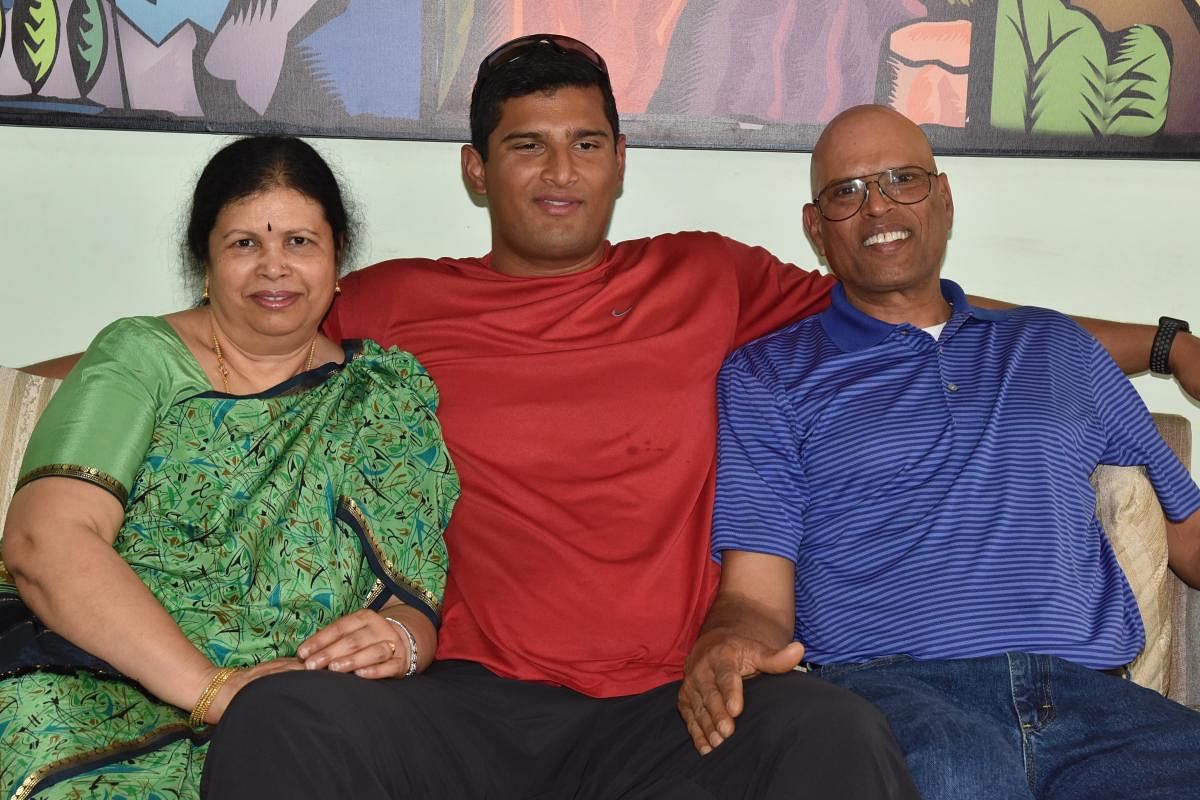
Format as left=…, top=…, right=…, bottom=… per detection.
left=679, top=106, right=1200, bottom=800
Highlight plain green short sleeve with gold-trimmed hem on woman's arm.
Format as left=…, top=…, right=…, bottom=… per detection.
left=17, top=317, right=184, bottom=506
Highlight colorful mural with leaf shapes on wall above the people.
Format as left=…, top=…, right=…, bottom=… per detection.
left=0, top=0, right=1200, bottom=157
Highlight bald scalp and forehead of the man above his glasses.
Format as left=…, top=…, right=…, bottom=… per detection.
left=809, top=106, right=937, bottom=197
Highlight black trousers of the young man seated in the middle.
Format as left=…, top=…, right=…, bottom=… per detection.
left=202, top=661, right=918, bottom=800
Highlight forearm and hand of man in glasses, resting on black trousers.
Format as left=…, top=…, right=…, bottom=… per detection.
left=678, top=551, right=804, bottom=754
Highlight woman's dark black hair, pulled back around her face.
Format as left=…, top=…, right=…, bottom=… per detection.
left=185, top=136, right=355, bottom=292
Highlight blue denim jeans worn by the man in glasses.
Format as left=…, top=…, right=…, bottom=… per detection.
left=816, top=652, right=1200, bottom=800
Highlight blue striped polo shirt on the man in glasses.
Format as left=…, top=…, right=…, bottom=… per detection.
left=713, top=281, right=1200, bottom=668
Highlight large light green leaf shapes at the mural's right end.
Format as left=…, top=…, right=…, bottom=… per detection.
left=991, top=0, right=1171, bottom=137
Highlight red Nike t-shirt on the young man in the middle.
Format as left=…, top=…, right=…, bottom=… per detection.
left=325, top=233, right=833, bottom=697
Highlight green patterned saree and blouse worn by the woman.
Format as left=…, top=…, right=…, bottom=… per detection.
left=0, top=318, right=458, bottom=799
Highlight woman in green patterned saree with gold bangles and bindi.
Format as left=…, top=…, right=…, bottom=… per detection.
left=0, top=137, right=458, bottom=799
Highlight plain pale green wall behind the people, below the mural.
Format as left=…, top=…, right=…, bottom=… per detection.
left=0, top=126, right=1200, bottom=475
